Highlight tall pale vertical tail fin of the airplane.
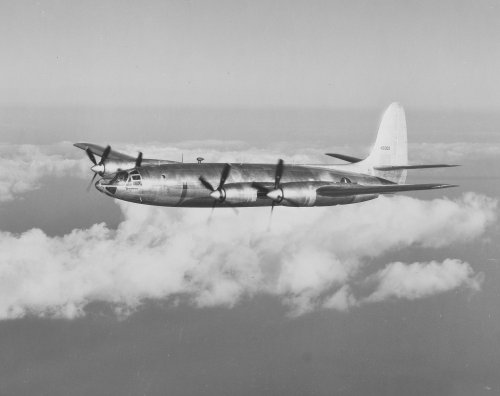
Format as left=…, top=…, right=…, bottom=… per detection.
left=359, top=103, right=408, bottom=183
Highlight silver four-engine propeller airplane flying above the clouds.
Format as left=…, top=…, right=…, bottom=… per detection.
left=74, top=103, right=458, bottom=212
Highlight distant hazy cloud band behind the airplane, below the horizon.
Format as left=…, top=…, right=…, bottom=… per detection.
left=0, top=140, right=500, bottom=203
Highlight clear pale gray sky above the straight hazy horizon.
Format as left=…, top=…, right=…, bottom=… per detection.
left=0, top=0, right=500, bottom=109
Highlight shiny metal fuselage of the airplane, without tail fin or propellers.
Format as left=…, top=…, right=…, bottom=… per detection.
left=96, top=163, right=391, bottom=207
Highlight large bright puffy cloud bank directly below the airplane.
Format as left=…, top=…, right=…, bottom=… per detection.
left=0, top=193, right=496, bottom=319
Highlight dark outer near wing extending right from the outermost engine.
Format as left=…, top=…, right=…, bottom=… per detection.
left=316, top=183, right=458, bottom=197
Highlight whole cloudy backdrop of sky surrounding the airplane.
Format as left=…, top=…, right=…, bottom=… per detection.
left=0, top=1, right=500, bottom=396
